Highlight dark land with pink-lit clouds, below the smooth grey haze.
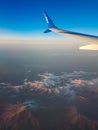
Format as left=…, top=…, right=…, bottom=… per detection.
left=0, top=71, right=98, bottom=130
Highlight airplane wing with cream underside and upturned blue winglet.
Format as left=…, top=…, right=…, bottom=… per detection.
left=44, top=12, right=98, bottom=49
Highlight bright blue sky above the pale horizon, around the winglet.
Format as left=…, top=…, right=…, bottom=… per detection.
left=0, top=0, right=98, bottom=38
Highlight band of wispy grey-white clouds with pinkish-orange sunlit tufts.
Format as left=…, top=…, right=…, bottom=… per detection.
left=0, top=71, right=98, bottom=94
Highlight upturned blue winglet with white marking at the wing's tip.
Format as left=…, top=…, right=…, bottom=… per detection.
left=44, top=11, right=57, bottom=33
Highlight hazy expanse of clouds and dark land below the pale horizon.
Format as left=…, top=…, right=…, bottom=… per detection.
left=0, top=40, right=98, bottom=130
